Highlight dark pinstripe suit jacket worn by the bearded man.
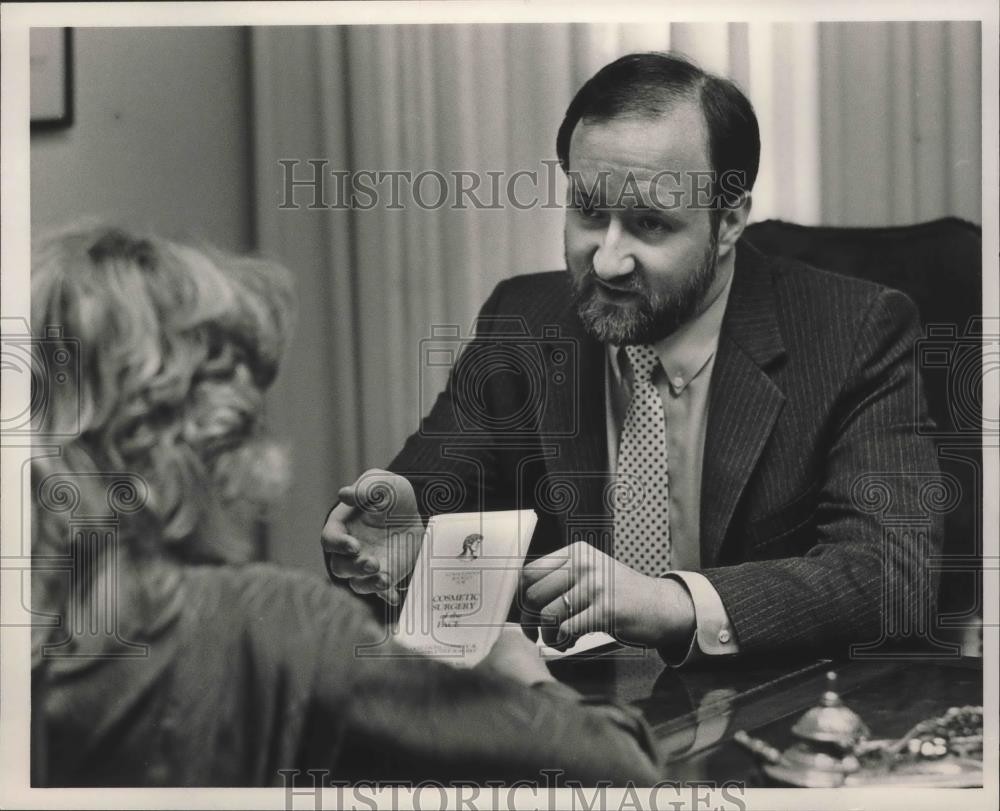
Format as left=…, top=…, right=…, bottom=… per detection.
left=390, top=242, right=940, bottom=653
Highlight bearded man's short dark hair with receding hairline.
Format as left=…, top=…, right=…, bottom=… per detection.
left=556, top=52, right=760, bottom=216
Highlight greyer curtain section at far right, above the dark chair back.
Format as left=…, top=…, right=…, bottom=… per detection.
left=820, top=21, right=982, bottom=225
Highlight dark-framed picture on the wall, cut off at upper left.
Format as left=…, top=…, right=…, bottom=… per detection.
left=29, top=28, right=73, bottom=130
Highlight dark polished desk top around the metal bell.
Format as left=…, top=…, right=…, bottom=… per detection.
left=550, top=649, right=983, bottom=787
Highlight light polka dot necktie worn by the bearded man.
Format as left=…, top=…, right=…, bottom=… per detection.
left=614, top=346, right=670, bottom=577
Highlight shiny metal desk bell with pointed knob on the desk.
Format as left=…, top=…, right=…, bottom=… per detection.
left=734, top=671, right=870, bottom=788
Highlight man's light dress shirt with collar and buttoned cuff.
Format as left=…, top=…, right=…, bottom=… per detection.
left=605, top=273, right=739, bottom=664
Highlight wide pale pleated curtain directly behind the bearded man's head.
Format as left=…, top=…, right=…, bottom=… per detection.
left=252, top=23, right=820, bottom=566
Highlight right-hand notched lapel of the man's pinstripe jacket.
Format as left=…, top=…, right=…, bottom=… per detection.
left=701, top=242, right=785, bottom=566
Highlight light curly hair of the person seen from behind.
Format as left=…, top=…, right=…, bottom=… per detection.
left=31, top=227, right=294, bottom=660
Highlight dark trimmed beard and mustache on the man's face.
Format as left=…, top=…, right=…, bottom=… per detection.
left=566, top=239, right=719, bottom=346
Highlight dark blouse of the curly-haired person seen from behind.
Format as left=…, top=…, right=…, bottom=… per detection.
left=32, top=564, right=656, bottom=786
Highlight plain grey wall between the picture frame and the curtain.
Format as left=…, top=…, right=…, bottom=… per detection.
left=31, top=28, right=252, bottom=250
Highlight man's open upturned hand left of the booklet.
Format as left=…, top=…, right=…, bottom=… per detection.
left=320, top=470, right=424, bottom=605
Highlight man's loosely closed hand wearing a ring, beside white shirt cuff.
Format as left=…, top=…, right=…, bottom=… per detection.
left=521, top=542, right=695, bottom=648
